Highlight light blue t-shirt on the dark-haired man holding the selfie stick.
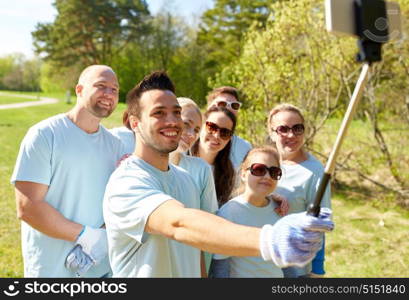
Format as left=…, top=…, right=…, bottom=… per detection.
left=104, top=155, right=201, bottom=277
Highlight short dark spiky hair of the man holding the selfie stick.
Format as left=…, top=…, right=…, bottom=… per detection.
left=123, top=71, right=176, bottom=129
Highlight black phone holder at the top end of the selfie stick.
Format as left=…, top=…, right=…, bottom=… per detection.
left=354, top=0, right=389, bottom=63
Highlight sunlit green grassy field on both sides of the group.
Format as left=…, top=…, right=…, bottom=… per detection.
left=0, top=90, right=409, bottom=278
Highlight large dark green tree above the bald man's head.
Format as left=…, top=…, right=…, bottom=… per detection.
left=32, top=0, right=149, bottom=67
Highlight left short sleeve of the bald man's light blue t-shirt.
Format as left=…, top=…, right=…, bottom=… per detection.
left=11, top=128, right=52, bottom=185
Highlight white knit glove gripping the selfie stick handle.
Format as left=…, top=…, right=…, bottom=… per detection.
left=260, top=208, right=334, bottom=268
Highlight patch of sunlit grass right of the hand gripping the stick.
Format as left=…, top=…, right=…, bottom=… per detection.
left=325, top=193, right=409, bottom=278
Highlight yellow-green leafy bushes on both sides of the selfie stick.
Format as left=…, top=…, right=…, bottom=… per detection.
left=210, top=0, right=409, bottom=202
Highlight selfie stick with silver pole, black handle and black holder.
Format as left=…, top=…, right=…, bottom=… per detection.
left=308, top=0, right=388, bottom=217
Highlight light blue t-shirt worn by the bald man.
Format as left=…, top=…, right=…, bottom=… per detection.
left=11, top=114, right=123, bottom=277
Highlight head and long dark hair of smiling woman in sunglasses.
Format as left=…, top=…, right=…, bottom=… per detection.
left=190, top=106, right=236, bottom=207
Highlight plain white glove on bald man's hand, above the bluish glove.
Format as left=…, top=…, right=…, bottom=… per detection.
left=76, top=226, right=108, bottom=265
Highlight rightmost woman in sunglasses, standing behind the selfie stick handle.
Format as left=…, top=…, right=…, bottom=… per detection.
left=267, top=104, right=331, bottom=278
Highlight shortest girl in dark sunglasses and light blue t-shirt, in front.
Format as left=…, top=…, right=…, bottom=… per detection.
left=210, top=147, right=283, bottom=278
